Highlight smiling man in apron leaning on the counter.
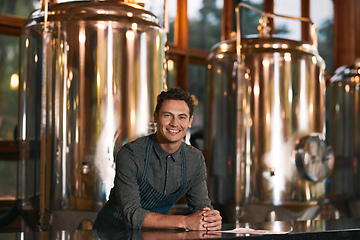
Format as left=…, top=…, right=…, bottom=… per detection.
left=93, top=88, right=222, bottom=231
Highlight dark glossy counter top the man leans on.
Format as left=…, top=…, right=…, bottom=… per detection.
left=0, top=219, right=360, bottom=240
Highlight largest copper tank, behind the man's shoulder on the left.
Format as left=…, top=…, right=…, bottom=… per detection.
left=20, top=1, right=165, bottom=229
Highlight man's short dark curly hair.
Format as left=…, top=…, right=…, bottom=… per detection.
left=155, top=88, right=194, bottom=118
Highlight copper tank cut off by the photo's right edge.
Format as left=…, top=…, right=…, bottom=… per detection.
left=326, top=60, right=360, bottom=218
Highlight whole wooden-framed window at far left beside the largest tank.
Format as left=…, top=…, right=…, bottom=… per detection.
left=0, top=0, right=35, bottom=201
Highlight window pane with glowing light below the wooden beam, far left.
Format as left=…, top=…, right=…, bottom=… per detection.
left=0, top=35, right=19, bottom=200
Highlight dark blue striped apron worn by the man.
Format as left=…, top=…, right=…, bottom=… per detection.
left=93, top=137, right=187, bottom=230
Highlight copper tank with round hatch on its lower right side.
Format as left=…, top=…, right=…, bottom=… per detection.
left=207, top=2, right=333, bottom=222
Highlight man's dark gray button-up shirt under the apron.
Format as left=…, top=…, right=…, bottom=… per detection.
left=111, top=134, right=213, bottom=229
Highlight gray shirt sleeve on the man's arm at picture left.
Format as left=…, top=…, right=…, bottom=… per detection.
left=114, top=145, right=149, bottom=229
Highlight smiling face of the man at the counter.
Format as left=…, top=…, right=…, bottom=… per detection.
left=154, top=100, right=192, bottom=143
